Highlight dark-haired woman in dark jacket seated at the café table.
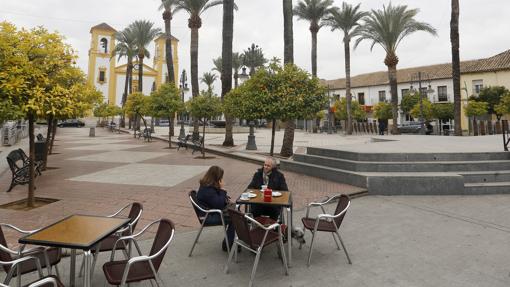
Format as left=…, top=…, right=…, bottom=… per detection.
left=197, top=165, right=235, bottom=251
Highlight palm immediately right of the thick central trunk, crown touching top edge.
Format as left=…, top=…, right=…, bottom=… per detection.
left=294, top=0, right=333, bottom=77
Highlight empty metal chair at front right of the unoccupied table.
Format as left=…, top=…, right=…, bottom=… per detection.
left=103, top=218, right=175, bottom=287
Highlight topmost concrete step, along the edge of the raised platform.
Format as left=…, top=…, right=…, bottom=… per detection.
left=307, top=147, right=510, bottom=162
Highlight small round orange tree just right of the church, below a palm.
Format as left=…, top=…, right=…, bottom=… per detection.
left=150, top=83, right=184, bottom=148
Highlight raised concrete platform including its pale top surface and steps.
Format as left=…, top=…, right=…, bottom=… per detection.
left=281, top=136, right=510, bottom=195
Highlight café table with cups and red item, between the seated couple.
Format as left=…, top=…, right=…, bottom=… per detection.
left=236, top=189, right=292, bottom=267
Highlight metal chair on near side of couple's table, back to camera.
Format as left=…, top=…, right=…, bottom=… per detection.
left=225, top=209, right=289, bottom=287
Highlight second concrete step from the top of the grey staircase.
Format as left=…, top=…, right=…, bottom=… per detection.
left=294, top=154, right=510, bottom=172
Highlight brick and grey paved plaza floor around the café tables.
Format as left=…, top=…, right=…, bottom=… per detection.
left=0, top=128, right=510, bottom=287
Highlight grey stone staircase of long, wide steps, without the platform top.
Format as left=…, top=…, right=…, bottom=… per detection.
left=280, top=147, right=510, bottom=195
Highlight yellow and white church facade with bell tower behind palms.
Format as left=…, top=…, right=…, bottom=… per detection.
left=87, top=23, right=179, bottom=106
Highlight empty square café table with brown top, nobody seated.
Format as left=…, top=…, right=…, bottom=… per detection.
left=19, top=214, right=129, bottom=287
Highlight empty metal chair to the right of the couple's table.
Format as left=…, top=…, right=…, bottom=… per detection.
left=299, top=194, right=352, bottom=266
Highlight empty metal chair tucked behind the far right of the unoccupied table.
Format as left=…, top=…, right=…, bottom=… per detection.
left=79, top=202, right=143, bottom=277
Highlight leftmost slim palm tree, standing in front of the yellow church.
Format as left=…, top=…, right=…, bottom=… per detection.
left=112, top=28, right=136, bottom=127
